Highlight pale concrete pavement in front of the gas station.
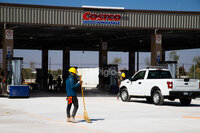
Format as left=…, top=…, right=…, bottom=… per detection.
left=0, top=95, right=200, bottom=133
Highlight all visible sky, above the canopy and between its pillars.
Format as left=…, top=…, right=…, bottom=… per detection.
left=0, top=0, right=200, bottom=70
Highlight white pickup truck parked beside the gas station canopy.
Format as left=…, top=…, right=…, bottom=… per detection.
left=119, top=67, right=200, bottom=106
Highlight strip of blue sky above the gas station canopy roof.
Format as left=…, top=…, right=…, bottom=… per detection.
left=0, top=0, right=200, bottom=11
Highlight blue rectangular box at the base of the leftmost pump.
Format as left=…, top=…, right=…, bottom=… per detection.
left=9, top=85, right=29, bottom=97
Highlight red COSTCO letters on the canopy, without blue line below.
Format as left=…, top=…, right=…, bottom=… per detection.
left=83, top=12, right=121, bottom=21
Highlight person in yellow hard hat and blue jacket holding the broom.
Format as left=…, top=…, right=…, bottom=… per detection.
left=66, top=67, right=82, bottom=123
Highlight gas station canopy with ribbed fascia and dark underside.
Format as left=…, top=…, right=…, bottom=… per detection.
left=0, top=3, right=200, bottom=51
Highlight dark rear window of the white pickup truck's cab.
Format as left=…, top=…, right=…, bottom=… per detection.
left=147, top=70, right=172, bottom=79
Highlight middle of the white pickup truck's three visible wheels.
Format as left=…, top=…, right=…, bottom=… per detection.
left=152, top=90, right=164, bottom=105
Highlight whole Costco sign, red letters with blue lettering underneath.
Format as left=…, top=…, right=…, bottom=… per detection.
left=83, top=12, right=121, bottom=25
